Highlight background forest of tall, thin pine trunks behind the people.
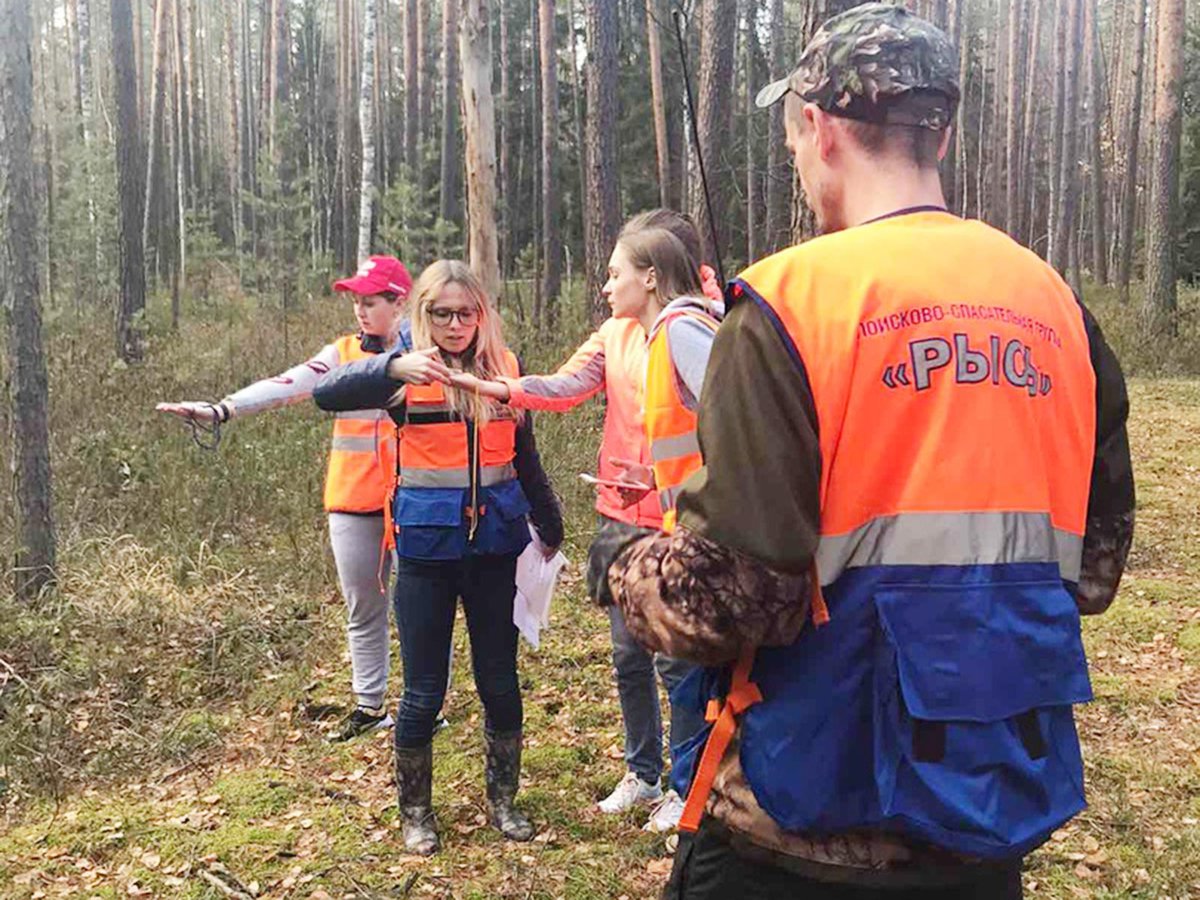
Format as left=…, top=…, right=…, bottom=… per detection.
left=9, top=0, right=1200, bottom=360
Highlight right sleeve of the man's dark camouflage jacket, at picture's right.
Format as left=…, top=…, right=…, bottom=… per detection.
left=1076, top=304, right=1135, bottom=614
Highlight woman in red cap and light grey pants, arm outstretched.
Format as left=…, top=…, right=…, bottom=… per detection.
left=157, top=257, right=422, bottom=740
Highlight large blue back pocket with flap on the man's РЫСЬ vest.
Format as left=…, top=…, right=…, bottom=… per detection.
left=875, top=580, right=1092, bottom=858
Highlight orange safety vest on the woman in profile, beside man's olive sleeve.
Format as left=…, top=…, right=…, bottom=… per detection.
left=644, top=308, right=719, bottom=534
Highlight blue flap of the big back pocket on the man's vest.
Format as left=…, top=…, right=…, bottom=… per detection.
left=875, top=581, right=1092, bottom=722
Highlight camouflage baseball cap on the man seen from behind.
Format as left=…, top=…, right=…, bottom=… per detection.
left=755, top=2, right=959, bottom=131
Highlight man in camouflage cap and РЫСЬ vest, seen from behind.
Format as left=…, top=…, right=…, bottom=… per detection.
left=608, top=4, right=1134, bottom=900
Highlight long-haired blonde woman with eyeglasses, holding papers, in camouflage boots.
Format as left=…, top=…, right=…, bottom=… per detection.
left=313, top=259, right=563, bottom=856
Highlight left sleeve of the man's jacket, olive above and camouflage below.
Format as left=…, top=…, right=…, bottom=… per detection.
left=608, top=301, right=821, bottom=665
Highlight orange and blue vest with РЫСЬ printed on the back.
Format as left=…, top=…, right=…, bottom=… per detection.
left=684, top=210, right=1096, bottom=858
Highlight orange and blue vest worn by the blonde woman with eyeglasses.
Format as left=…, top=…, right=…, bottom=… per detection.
left=392, top=352, right=529, bottom=560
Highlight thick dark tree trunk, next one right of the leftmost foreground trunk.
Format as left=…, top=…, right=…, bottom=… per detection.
left=111, top=0, right=145, bottom=362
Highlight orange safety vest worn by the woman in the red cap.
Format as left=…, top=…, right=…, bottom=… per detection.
left=325, top=335, right=396, bottom=512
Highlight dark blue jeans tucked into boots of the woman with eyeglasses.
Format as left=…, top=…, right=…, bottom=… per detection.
left=392, top=554, right=523, bottom=748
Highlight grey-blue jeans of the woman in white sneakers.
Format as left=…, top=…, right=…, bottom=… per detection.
left=608, top=606, right=704, bottom=785
